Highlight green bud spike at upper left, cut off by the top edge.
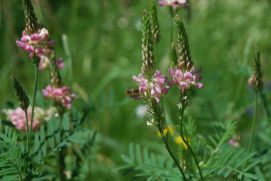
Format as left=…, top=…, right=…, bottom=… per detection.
left=23, top=0, right=39, bottom=33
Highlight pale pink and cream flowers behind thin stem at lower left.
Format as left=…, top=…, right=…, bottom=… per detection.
left=3, top=107, right=55, bottom=131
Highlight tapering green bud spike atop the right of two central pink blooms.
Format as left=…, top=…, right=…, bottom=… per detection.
left=175, top=16, right=193, bottom=69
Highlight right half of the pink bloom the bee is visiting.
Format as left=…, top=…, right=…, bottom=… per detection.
left=150, top=70, right=169, bottom=103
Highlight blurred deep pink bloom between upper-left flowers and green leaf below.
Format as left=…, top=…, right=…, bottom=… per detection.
left=42, top=85, right=76, bottom=109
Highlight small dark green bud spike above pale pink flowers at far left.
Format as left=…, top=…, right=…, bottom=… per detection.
left=11, top=76, right=29, bottom=110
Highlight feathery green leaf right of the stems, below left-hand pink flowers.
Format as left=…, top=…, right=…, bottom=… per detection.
left=32, top=114, right=92, bottom=163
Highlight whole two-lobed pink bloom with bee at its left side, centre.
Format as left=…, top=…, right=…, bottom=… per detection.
left=133, top=70, right=169, bottom=103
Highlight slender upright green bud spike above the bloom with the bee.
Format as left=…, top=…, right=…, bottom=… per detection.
left=141, top=11, right=154, bottom=75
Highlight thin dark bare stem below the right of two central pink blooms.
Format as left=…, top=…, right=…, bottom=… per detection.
left=180, top=99, right=204, bottom=181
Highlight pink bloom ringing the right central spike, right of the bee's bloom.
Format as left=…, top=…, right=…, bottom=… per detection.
left=169, top=68, right=203, bottom=92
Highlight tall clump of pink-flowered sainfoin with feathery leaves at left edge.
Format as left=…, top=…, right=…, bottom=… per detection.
left=0, top=0, right=95, bottom=181
